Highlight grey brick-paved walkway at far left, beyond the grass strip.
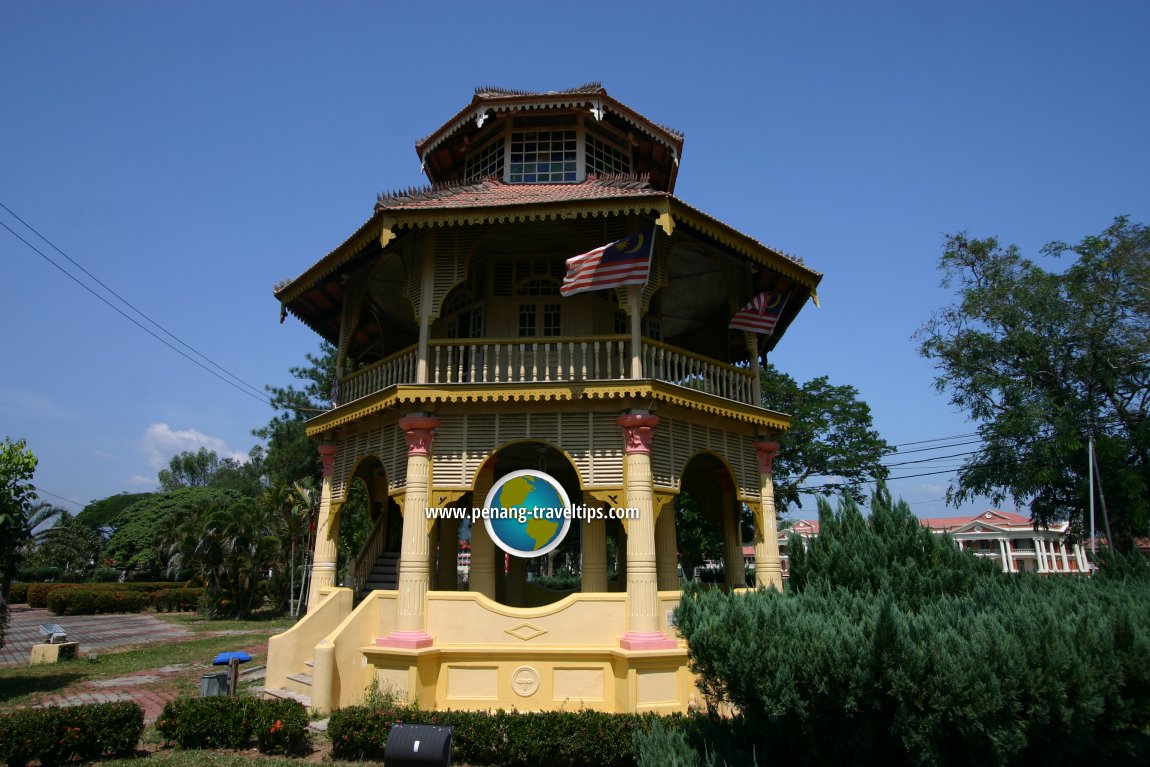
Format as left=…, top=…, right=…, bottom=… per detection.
left=0, top=606, right=192, bottom=666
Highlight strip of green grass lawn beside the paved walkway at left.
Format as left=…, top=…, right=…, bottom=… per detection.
left=0, top=614, right=292, bottom=707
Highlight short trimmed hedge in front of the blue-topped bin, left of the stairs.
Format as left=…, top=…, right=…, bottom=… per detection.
left=155, top=696, right=308, bottom=754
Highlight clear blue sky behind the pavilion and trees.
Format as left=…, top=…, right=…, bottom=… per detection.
left=0, top=0, right=1150, bottom=516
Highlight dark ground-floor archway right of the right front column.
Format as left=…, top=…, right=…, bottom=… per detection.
left=674, top=453, right=753, bottom=589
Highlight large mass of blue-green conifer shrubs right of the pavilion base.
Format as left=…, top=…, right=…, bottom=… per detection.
left=675, top=490, right=1150, bottom=765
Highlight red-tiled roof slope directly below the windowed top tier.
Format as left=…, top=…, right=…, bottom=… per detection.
left=375, top=175, right=669, bottom=213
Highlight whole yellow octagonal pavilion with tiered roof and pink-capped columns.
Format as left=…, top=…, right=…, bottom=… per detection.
left=266, top=84, right=821, bottom=713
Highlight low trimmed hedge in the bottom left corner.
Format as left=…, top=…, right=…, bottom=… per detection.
left=0, top=701, right=144, bottom=767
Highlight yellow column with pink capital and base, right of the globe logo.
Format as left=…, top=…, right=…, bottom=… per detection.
left=618, top=413, right=679, bottom=650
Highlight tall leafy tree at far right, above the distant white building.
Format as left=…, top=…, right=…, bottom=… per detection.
left=917, top=218, right=1150, bottom=551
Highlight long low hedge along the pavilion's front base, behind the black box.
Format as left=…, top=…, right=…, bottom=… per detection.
left=328, top=705, right=657, bottom=767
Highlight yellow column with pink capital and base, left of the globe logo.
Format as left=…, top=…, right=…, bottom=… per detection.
left=376, top=413, right=439, bottom=650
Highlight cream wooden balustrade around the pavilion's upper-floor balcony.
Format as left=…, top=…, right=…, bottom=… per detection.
left=338, top=336, right=754, bottom=405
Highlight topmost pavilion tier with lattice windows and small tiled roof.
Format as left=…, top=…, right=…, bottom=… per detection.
left=415, top=83, right=683, bottom=192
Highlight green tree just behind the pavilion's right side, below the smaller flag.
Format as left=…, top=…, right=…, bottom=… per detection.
left=761, top=363, right=895, bottom=512
